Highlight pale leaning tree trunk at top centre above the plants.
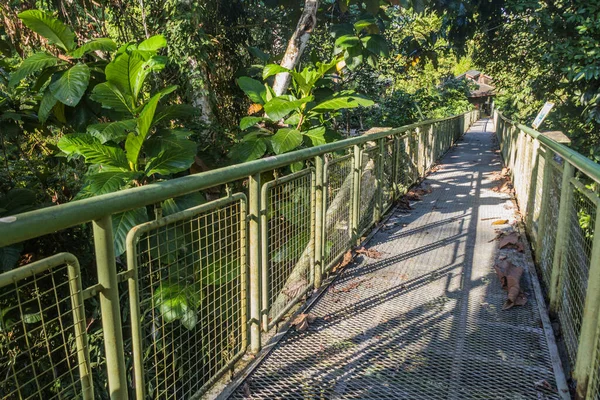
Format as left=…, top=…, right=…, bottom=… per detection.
left=273, top=0, right=319, bottom=96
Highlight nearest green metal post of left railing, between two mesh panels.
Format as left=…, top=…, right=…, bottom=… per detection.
left=92, top=215, right=128, bottom=400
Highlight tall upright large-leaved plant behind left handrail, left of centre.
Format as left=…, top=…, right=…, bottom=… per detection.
left=58, top=35, right=196, bottom=255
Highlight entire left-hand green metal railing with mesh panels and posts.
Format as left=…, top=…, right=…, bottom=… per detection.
left=0, top=111, right=479, bottom=400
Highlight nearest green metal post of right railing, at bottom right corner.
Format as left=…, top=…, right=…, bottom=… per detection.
left=573, top=208, right=600, bottom=399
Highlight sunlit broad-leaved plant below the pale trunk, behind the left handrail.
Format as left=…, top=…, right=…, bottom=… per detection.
left=229, top=60, right=374, bottom=169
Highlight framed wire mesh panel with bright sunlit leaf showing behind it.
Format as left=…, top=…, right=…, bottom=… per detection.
left=127, top=194, right=247, bottom=399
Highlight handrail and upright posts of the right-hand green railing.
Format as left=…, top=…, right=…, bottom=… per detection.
left=494, top=110, right=600, bottom=400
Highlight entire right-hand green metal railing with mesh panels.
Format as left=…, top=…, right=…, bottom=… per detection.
left=494, top=111, right=600, bottom=399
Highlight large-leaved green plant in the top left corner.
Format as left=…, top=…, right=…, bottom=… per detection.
left=9, top=10, right=117, bottom=123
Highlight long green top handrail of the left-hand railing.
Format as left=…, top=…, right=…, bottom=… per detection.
left=0, top=113, right=464, bottom=247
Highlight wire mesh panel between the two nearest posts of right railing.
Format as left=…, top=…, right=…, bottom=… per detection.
left=558, top=181, right=596, bottom=364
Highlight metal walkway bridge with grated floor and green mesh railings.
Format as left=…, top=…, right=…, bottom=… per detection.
left=0, top=111, right=600, bottom=400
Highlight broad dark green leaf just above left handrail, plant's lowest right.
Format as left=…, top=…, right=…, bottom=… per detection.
left=146, top=139, right=197, bottom=175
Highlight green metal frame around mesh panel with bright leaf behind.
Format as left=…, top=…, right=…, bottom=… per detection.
left=126, top=193, right=249, bottom=400
